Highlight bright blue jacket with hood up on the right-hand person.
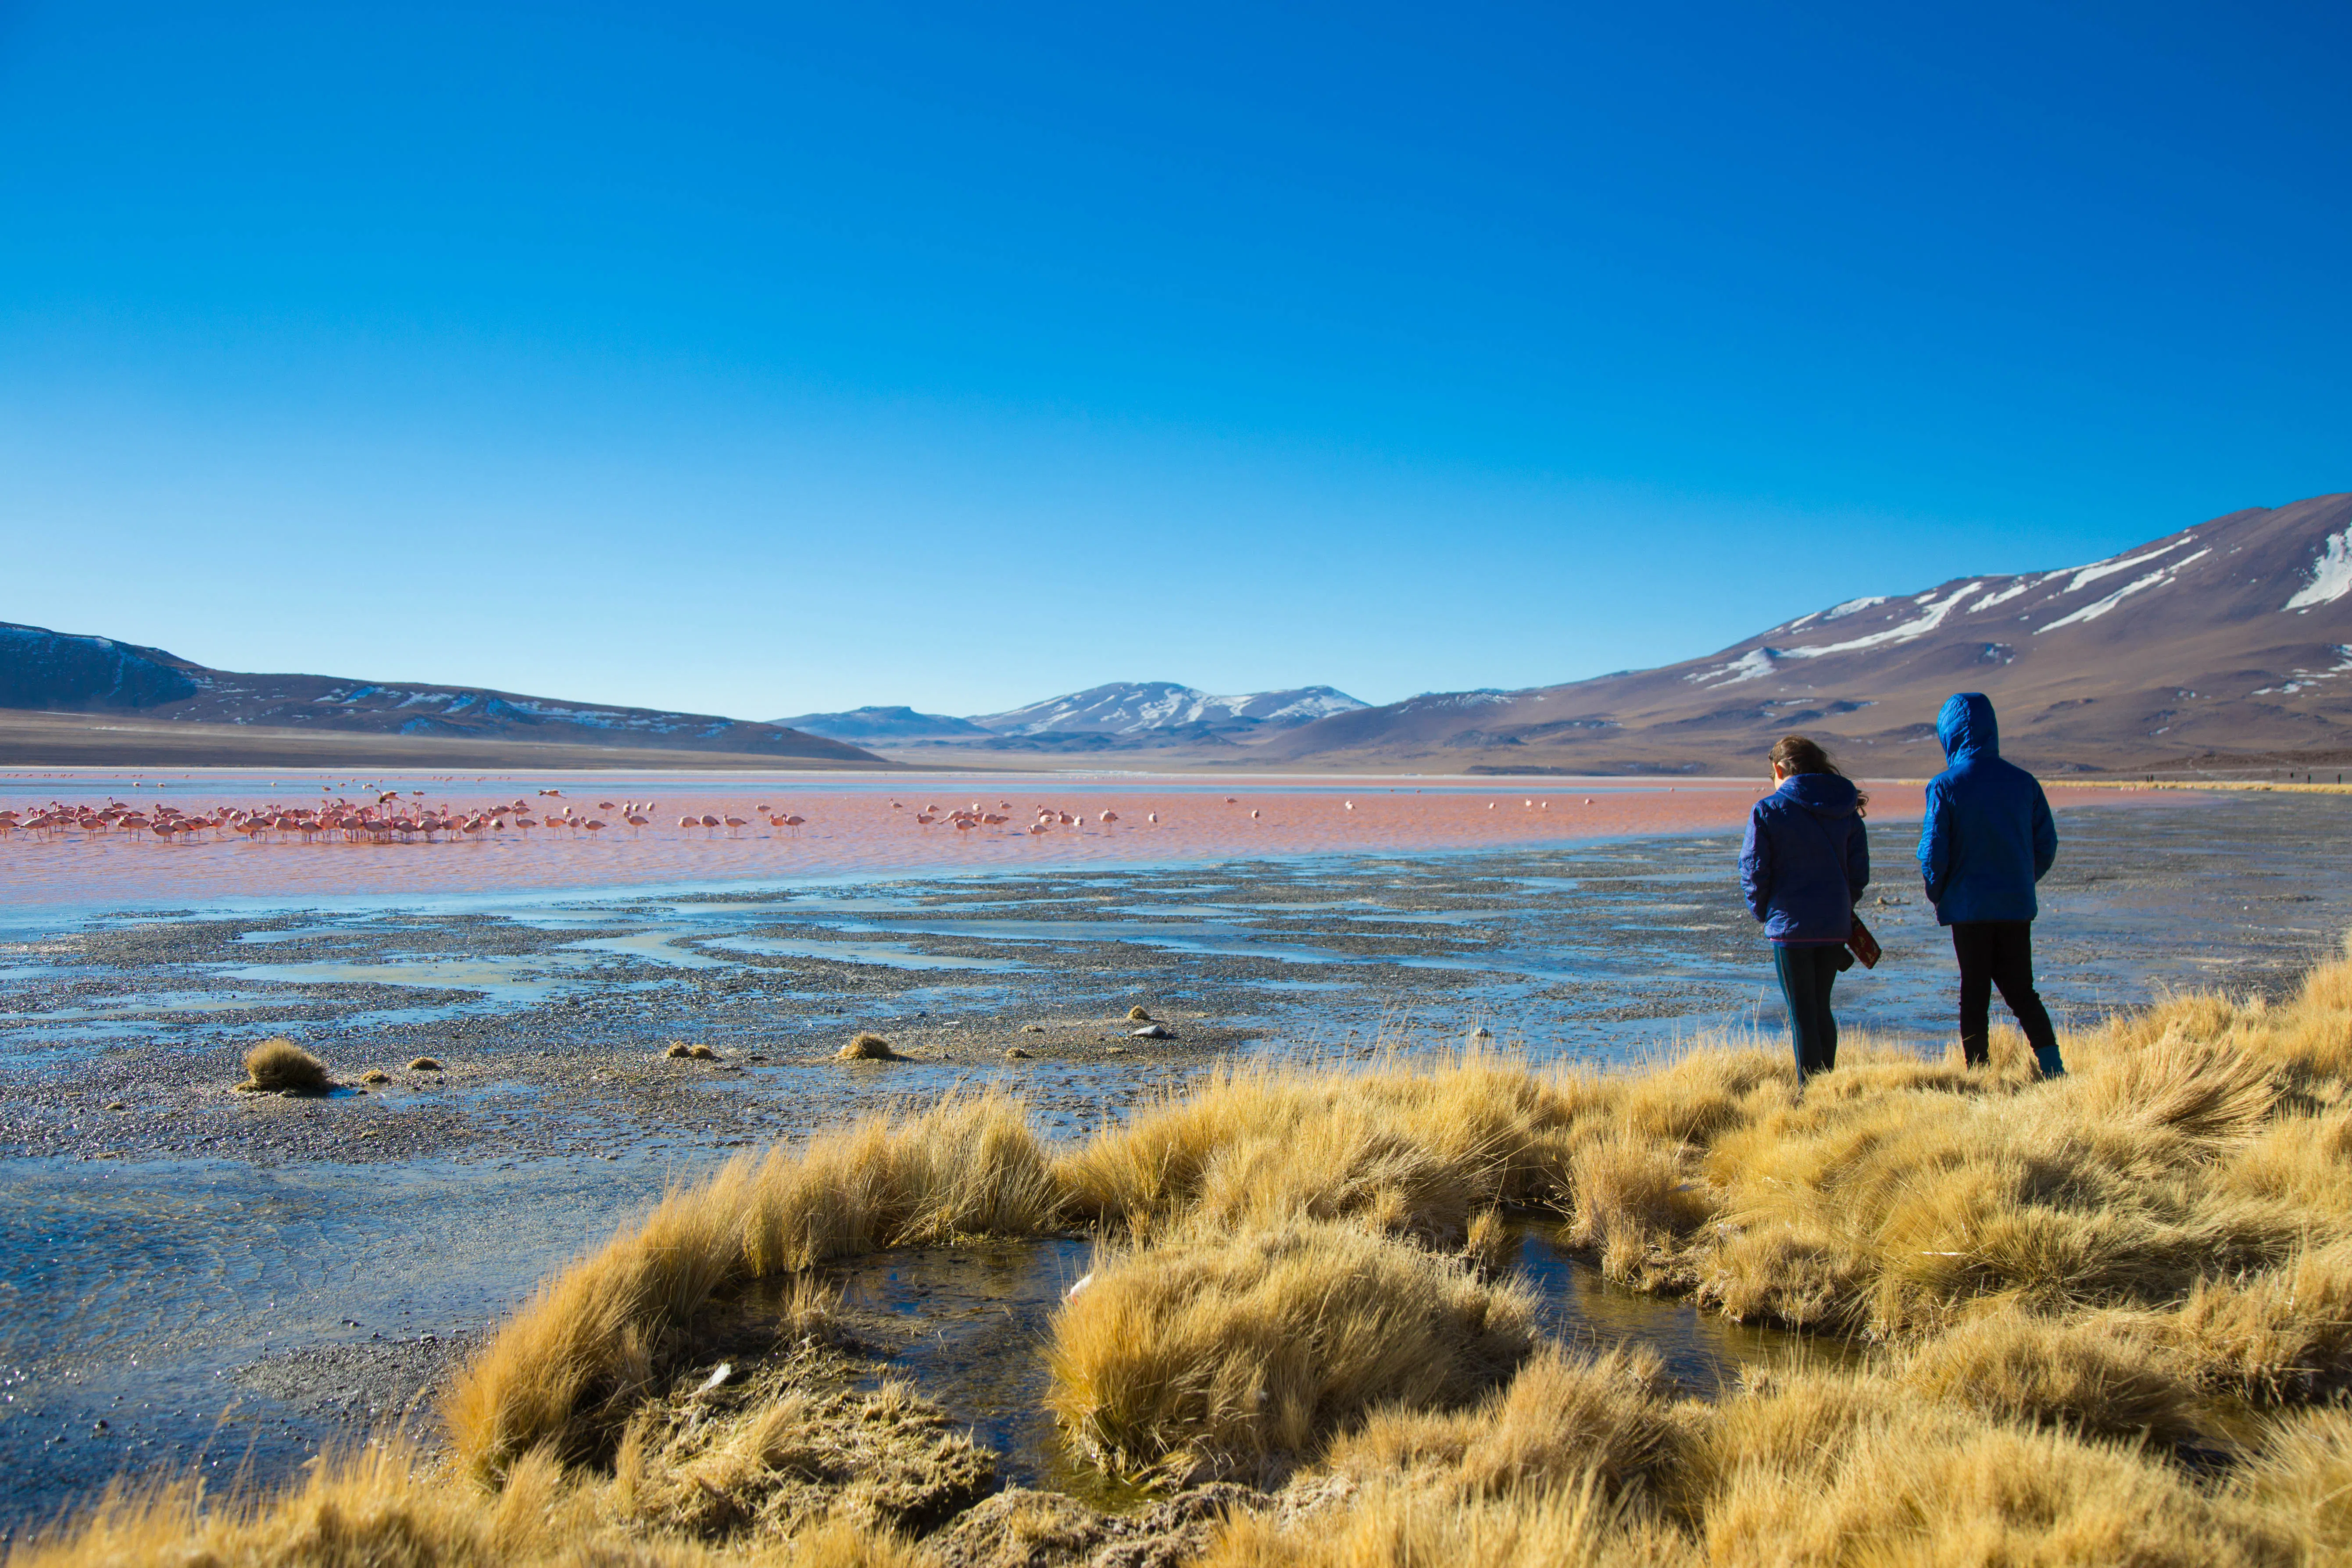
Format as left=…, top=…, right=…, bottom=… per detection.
left=1919, top=691, right=2058, bottom=926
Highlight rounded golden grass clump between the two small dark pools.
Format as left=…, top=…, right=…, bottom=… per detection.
left=1047, top=1222, right=1533, bottom=1474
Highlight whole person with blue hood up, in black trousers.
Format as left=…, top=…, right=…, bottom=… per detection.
left=1919, top=691, right=2065, bottom=1077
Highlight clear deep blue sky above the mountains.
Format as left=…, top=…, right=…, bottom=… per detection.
left=0, top=0, right=2352, bottom=717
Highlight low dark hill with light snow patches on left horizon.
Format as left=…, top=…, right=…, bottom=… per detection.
left=0, top=623, right=886, bottom=766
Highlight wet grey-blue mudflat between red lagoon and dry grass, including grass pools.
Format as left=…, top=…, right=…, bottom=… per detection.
left=0, top=797, right=2352, bottom=1523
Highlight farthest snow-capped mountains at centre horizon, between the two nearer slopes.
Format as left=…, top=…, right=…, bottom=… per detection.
left=776, top=682, right=1364, bottom=752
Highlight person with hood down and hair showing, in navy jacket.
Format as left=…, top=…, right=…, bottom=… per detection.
left=1741, top=736, right=1870, bottom=1089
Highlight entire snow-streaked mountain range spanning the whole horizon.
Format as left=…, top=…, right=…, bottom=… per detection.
left=0, top=494, right=2352, bottom=776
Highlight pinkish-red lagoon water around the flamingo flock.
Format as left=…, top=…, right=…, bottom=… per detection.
left=0, top=771, right=1919, bottom=905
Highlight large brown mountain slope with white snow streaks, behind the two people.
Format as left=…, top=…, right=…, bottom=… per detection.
left=1251, top=496, right=2352, bottom=773
